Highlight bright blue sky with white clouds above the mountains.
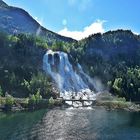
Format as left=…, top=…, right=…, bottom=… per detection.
left=4, top=0, right=140, bottom=40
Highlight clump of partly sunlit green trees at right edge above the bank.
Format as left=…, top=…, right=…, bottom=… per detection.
left=108, top=66, right=140, bottom=101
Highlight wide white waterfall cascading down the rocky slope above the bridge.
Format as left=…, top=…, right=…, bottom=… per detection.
left=43, top=50, right=95, bottom=105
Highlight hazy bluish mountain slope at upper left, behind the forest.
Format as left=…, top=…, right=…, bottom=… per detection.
left=0, top=0, right=74, bottom=43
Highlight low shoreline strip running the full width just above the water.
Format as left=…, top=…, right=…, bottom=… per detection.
left=0, top=95, right=140, bottom=113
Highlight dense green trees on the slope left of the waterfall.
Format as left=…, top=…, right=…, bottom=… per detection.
left=0, top=33, right=51, bottom=98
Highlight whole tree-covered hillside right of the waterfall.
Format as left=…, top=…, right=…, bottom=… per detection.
left=71, top=30, right=140, bottom=102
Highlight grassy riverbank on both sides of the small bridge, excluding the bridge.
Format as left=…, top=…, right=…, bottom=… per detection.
left=0, top=93, right=140, bottom=112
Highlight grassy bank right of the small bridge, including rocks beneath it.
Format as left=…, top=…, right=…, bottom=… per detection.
left=62, top=92, right=140, bottom=112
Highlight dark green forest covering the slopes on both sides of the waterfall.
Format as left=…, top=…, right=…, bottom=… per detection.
left=0, top=30, right=140, bottom=102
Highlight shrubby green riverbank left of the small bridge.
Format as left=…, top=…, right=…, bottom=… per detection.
left=0, top=97, right=62, bottom=112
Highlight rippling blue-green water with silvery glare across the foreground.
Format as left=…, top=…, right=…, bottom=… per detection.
left=0, top=108, right=140, bottom=140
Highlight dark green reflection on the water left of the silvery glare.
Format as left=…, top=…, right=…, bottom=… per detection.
left=0, top=110, right=46, bottom=140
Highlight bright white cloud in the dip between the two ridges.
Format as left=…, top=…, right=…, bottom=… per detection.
left=58, top=20, right=106, bottom=40
